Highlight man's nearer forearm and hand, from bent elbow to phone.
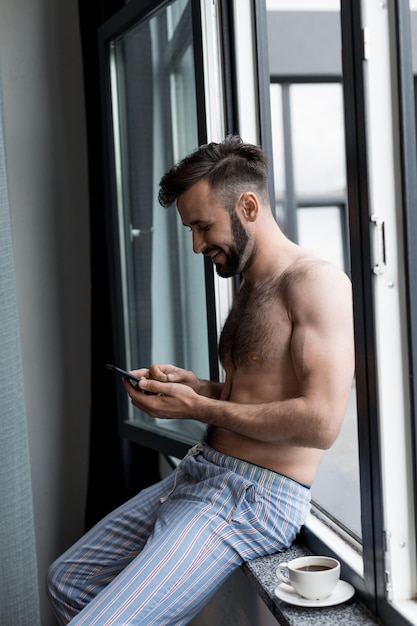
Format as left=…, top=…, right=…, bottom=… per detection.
left=125, top=377, right=346, bottom=450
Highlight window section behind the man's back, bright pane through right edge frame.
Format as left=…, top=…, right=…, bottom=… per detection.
left=268, top=0, right=417, bottom=624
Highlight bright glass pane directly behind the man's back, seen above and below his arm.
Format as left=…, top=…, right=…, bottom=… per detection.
left=268, top=2, right=362, bottom=538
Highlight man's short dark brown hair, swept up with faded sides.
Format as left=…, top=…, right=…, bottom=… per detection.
left=158, top=135, right=268, bottom=211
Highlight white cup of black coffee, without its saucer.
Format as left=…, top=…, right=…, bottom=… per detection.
left=276, top=556, right=340, bottom=600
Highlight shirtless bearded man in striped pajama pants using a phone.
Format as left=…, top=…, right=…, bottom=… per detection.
left=49, top=136, right=354, bottom=626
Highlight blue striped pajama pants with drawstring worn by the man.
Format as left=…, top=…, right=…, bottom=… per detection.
left=47, top=444, right=310, bottom=626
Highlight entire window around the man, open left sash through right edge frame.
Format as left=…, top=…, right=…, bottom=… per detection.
left=97, top=0, right=417, bottom=624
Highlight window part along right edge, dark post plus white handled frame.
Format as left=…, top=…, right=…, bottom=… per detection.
left=342, top=0, right=417, bottom=624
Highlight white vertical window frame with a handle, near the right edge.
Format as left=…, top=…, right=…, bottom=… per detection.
left=362, top=0, right=417, bottom=623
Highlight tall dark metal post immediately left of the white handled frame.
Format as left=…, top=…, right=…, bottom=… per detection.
left=341, top=0, right=385, bottom=613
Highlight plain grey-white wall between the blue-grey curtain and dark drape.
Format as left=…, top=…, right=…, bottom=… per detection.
left=0, top=0, right=90, bottom=626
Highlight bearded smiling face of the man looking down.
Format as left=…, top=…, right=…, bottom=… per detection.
left=177, top=180, right=252, bottom=278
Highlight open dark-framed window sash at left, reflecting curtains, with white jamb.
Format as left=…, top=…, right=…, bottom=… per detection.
left=100, top=0, right=267, bottom=457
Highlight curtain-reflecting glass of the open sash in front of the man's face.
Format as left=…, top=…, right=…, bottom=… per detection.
left=111, top=0, right=209, bottom=443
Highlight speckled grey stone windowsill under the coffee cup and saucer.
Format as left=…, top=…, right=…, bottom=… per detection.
left=241, top=543, right=379, bottom=626
